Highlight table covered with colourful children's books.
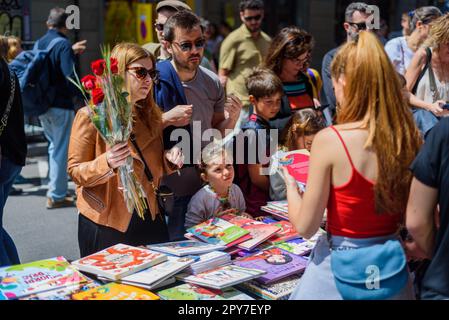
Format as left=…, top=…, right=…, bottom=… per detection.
left=0, top=201, right=325, bottom=300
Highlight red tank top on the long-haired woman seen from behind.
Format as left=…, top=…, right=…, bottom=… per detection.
left=327, top=126, right=401, bottom=238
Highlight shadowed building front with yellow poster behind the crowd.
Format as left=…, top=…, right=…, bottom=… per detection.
left=0, top=0, right=449, bottom=74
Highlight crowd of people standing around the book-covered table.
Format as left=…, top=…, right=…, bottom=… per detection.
left=0, top=0, right=449, bottom=299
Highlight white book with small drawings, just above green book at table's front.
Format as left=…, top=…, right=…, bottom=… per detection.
left=176, top=265, right=266, bottom=289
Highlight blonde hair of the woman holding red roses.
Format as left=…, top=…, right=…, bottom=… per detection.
left=111, top=42, right=162, bottom=137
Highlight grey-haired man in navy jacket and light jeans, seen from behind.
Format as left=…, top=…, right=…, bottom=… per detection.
left=37, top=8, right=87, bottom=209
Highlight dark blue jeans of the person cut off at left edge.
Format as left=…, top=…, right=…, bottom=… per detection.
left=0, top=157, right=22, bottom=267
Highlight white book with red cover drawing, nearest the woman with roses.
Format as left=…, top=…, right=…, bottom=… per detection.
left=72, top=244, right=167, bottom=280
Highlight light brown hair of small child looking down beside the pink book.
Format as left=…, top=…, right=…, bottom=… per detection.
left=280, top=108, right=326, bottom=151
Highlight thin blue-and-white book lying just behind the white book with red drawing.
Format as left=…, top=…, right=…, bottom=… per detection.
left=147, top=240, right=226, bottom=257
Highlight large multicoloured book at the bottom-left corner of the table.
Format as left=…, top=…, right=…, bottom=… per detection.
left=0, top=257, right=88, bottom=300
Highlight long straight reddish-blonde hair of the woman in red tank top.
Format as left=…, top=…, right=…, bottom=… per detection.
left=331, top=31, right=422, bottom=214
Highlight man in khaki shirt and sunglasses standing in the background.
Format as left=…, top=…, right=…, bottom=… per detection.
left=218, top=0, right=271, bottom=129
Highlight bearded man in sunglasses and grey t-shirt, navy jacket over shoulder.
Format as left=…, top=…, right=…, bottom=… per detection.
left=155, top=10, right=242, bottom=241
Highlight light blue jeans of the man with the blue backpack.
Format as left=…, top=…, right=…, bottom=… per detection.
left=39, top=108, right=75, bottom=201
